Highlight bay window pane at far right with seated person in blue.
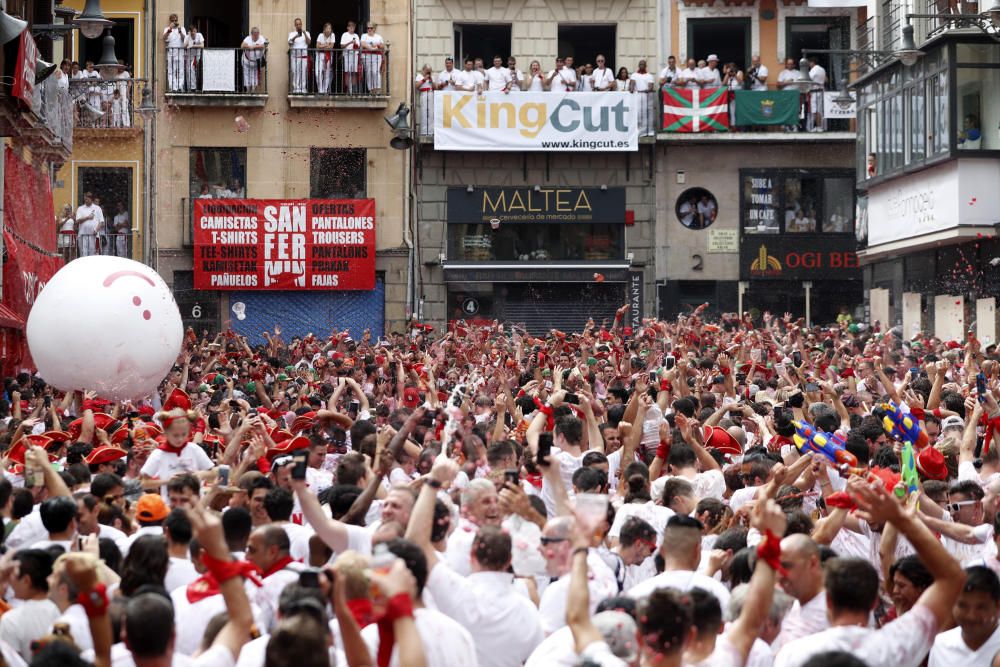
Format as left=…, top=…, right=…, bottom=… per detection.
left=955, top=68, right=1000, bottom=150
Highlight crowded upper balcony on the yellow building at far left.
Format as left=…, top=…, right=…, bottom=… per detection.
left=69, top=79, right=147, bottom=138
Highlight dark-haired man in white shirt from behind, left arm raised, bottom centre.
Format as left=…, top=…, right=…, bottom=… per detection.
left=406, top=459, right=543, bottom=667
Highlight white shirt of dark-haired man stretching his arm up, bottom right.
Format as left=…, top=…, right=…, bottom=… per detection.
left=774, top=604, right=938, bottom=667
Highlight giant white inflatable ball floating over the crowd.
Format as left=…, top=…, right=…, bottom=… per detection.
left=27, top=255, right=184, bottom=400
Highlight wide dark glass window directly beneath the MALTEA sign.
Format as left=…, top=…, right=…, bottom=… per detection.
left=448, top=223, right=625, bottom=262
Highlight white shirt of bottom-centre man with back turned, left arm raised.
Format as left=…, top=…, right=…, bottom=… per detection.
left=427, top=564, right=543, bottom=667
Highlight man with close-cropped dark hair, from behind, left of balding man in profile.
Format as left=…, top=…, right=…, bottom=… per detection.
left=628, top=515, right=729, bottom=609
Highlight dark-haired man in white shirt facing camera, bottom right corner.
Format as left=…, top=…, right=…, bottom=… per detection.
left=927, top=567, right=1000, bottom=667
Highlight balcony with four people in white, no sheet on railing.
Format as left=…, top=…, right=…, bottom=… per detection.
left=288, top=48, right=390, bottom=109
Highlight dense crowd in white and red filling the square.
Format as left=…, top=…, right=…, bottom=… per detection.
left=0, top=307, right=1000, bottom=667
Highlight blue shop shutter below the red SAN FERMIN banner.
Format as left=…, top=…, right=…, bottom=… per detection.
left=229, top=278, right=385, bottom=345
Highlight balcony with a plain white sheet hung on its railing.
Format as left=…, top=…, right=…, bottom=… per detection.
left=165, top=46, right=271, bottom=107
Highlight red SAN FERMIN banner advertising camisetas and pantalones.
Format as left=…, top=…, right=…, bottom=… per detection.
left=192, top=199, right=375, bottom=290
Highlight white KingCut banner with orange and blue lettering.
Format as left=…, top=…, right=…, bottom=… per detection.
left=434, top=91, right=645, bottom=152
